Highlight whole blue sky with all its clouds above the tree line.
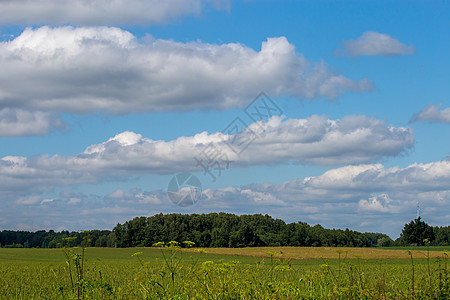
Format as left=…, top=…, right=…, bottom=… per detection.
left=0, top=0, right=450, bottom=238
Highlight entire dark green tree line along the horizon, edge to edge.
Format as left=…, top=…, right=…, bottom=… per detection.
left=0, top=213, right=450, bottom=248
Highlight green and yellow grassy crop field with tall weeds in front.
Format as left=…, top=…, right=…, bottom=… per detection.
left=0, top=244, right=449, bottom=299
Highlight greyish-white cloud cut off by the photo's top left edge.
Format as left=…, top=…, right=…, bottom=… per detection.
left=0, top=0, right=230, bottom=25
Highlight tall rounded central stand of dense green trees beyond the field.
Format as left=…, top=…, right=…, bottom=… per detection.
left=113, top=213, right=392, bottom=248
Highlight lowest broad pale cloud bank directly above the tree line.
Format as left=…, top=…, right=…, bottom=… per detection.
left=0, top=161, right=450, bottom=238
